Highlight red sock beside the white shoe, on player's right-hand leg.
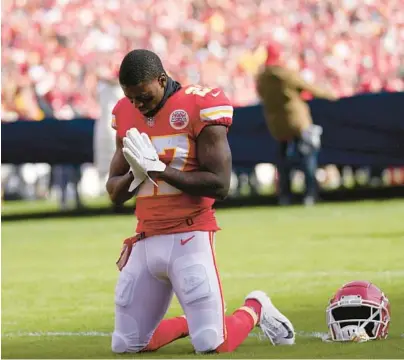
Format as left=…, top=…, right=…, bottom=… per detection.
left=216, top=306, right=258, bottom=353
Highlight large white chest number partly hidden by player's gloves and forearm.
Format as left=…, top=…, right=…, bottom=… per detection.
left=137, top=134, right=190, bottom=197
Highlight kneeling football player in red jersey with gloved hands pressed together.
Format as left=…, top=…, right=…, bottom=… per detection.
left=107, top=50, right=295, bottom=353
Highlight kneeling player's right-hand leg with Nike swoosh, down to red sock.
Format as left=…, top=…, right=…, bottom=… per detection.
left=169, top=231, right=258, bottom=353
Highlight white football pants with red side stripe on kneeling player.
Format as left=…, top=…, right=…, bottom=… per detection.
left=112, top=231, right=225, bottom=353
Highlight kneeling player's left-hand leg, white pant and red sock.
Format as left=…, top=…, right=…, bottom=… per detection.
left=112, top=238, right=181, bottom=353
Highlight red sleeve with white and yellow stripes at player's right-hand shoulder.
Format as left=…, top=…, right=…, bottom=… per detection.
left=193, top=88, right=233, bottom=137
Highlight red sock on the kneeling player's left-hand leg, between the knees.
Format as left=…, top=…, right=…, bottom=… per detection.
left=143, top=317, right=189, bottom=351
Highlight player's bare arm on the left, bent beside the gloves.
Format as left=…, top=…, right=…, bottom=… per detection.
left=106, top=135, right=135, bottom=204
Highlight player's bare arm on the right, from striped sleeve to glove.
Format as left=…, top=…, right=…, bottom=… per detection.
left=149, top=125, right=232, bottom=200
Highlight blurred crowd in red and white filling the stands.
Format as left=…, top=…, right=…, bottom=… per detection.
left=1, top=0, right=404, bottom=121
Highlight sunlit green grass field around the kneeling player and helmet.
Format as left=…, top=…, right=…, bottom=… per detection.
left=2, top=200, right=404, bottom=359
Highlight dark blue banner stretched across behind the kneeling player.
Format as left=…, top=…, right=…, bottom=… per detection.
left=1, top=93, right=404, bottom=166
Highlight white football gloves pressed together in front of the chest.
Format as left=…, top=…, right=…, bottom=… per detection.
left=122, top=128, right=166, bottom=186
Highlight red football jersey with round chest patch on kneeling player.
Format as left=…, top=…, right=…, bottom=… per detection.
left=112, top=86, right=233, bottom=236
